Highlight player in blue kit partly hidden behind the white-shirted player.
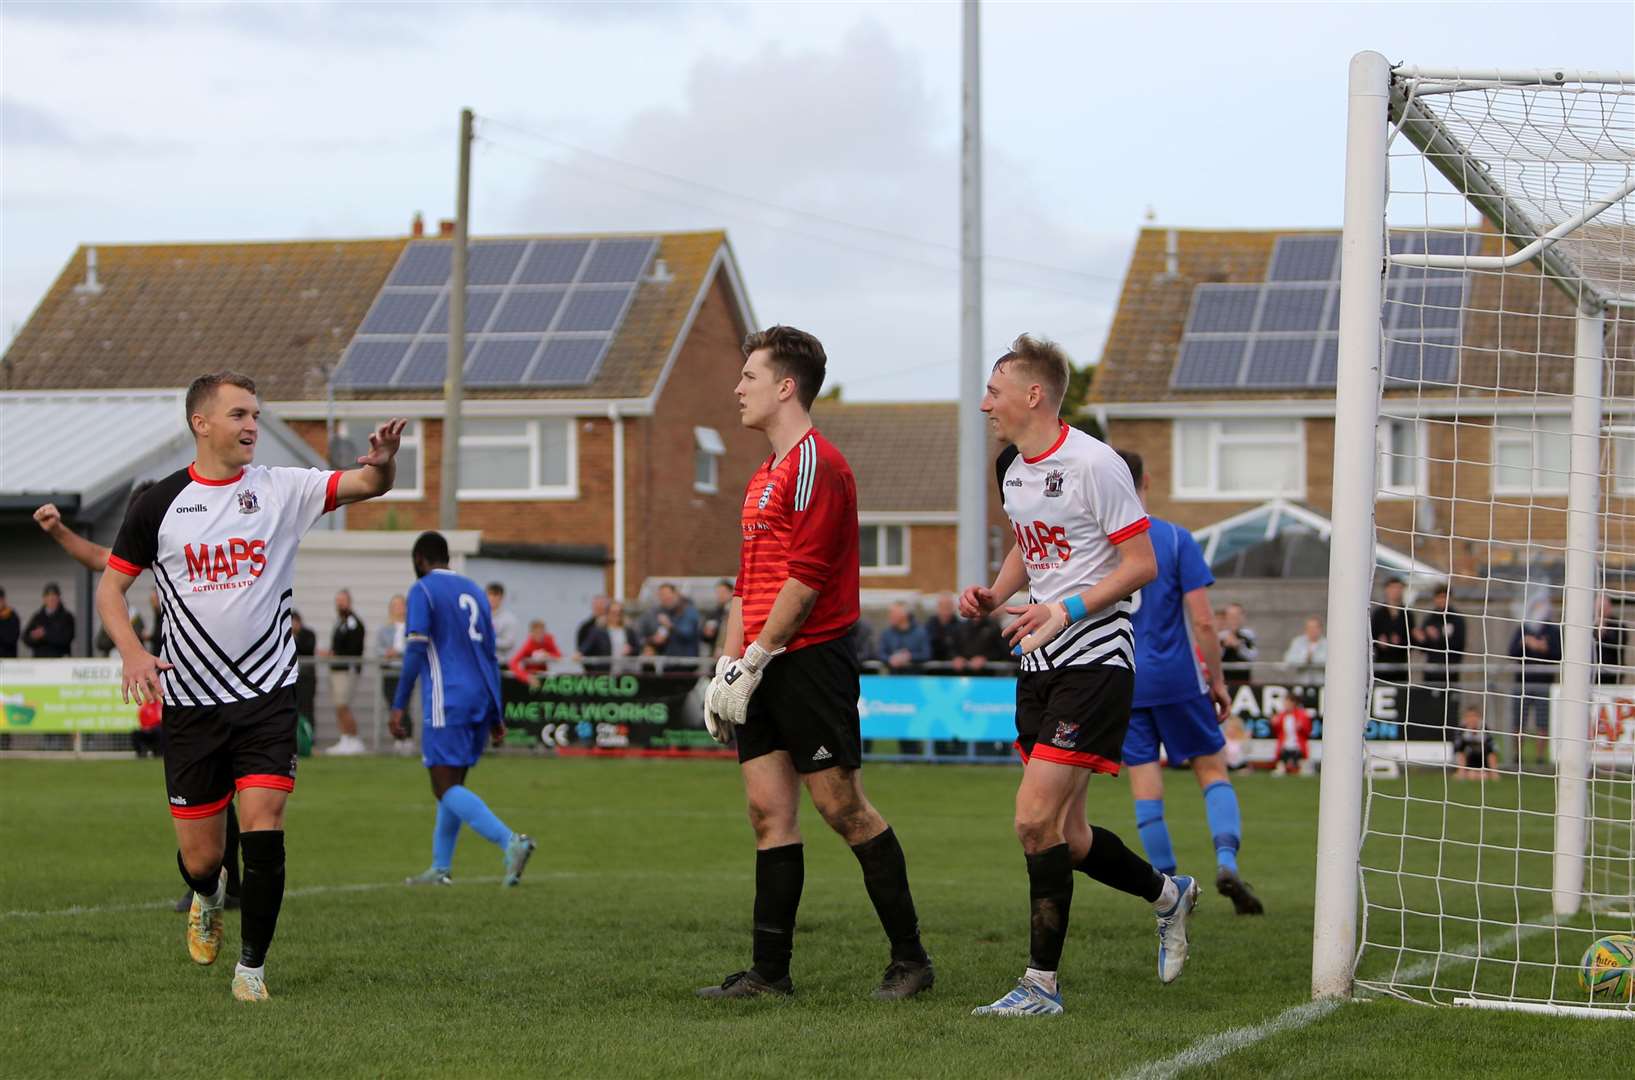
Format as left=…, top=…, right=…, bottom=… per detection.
left=1118, top=451, right=1265, bottom=915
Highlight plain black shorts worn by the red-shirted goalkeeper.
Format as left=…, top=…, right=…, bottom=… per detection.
left=737, top=637, right=863, bottom=773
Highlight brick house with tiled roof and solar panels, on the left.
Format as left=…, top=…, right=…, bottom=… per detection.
left=0, top=232, right=764, bottom=640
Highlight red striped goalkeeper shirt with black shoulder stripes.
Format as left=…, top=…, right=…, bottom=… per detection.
left=734, top=428, right=860, bottom=652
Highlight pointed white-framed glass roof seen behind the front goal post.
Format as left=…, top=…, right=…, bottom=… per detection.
left=1192, top=498, right=1447, bottom=583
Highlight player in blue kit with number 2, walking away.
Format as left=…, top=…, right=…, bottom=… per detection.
left=391, top=533, right=535, bottom=886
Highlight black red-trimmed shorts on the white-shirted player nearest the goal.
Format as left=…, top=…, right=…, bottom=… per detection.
left=1015, top=663, right=1135, bottom=776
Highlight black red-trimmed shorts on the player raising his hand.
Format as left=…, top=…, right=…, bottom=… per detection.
left=164, top=685, right=296, bottom=819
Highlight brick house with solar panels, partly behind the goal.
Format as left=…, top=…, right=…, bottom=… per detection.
left=1089, top=227, right=1635, bottom=577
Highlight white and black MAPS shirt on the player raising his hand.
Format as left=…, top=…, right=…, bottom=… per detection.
left=108, top=466, right=340, bottom=706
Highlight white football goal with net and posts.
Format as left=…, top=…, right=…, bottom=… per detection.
left=1313, top=54, right=1635, bottom=1020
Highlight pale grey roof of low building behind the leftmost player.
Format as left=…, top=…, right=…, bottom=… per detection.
left=0, top=390, right=324, bottom=516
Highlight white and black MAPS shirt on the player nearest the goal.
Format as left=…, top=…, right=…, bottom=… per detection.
left=996, top=425, right=1151, bottom=672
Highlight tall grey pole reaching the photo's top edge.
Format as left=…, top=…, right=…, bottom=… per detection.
left=956, top=0, right=989, bottom=588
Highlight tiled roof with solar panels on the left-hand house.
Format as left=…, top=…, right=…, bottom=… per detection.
left=0, top=230, right=754, bottom=410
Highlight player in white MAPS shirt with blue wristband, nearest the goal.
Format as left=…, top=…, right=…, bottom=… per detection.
left=960, top=335, right=1198, bottom=1016
